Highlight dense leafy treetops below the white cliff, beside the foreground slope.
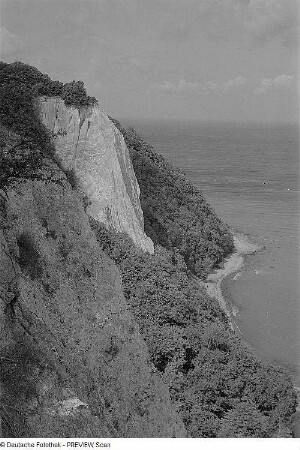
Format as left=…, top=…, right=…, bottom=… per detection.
left=91, top=220, right=296, bottom=437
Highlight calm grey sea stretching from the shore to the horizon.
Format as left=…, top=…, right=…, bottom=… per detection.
left=125, top=120, right=300, bottom=386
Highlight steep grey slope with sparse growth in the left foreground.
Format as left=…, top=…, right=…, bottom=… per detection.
left=0, top=157, right=185, bottom=437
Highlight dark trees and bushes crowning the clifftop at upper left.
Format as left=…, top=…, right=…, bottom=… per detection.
left=0, top=62, right=97, bottom=188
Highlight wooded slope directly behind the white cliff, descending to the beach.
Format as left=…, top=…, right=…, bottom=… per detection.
left=110, top=121, right=233, bottom=278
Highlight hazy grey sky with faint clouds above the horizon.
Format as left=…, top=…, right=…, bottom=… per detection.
left=0, top=0, right=298, bottom=121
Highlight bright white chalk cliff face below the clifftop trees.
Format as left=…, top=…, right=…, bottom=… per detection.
left=39, top=98, right=154, bottom=253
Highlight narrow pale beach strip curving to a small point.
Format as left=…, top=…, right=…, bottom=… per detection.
left=203, top=233, right=261, bottom=329
